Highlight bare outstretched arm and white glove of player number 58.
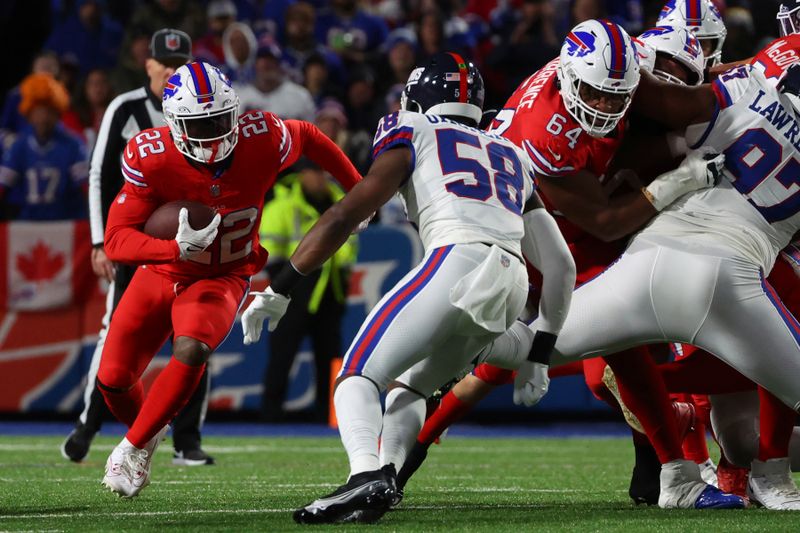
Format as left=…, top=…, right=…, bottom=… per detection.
left=242, top=146, right=411, bottom=344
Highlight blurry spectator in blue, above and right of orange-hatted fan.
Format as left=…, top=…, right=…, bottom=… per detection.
left=45, top=0, right=123, bottom=74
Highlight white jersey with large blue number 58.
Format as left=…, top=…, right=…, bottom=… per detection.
left=373, top=111, right=535, bottom=256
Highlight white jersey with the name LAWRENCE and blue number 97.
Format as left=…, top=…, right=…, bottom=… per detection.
left=640, top=66, right=800, bottom=272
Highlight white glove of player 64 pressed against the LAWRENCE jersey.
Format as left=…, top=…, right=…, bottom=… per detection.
left=643, top=152, right=725, bottom=211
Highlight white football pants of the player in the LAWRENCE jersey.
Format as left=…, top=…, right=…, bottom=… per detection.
left=531, top=235, right=800, bottom=410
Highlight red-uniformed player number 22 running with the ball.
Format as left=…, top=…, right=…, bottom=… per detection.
left=97, top=62, right=361, bottom=497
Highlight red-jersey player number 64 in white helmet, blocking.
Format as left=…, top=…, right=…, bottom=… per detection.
left=398, top=21, right=739, bottom=507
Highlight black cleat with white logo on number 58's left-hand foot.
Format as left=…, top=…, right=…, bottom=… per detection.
left=292, top=465, right=394, bottom=524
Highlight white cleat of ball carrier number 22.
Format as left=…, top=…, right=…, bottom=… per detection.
left=103, top=426, right=169, bottom=498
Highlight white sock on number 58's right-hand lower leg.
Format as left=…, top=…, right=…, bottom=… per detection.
left=381, top=387, right=426, bottom=470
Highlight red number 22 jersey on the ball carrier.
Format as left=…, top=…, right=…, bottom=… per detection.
left=105, top=111, right=360, bottom=280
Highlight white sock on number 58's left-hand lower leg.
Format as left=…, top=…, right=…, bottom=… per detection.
left=333, top=376, right=383, bottom=476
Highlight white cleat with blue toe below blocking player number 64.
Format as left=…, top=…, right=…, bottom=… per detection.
left=658, top=459, right=745, bottom=509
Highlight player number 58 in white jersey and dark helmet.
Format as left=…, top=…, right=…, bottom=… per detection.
left=242, top=53, right=575, bottom=523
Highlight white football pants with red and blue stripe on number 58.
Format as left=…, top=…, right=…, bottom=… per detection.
left=340, top=243, right=528, bottom=397
